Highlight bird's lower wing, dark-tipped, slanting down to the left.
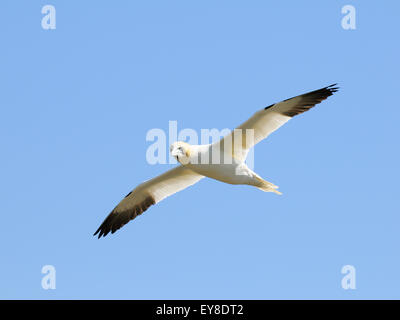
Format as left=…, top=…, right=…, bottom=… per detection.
left=94, top=166, right=204, bottom=238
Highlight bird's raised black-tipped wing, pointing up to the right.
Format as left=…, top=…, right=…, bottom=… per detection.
left=216, top=84, right=338, bottom=161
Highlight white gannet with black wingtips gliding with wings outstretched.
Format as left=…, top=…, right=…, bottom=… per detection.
left=94, top=84, right=338, bottom=238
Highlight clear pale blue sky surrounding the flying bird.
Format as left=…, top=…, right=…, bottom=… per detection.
left=0, top=0, right=400, bottom=299
